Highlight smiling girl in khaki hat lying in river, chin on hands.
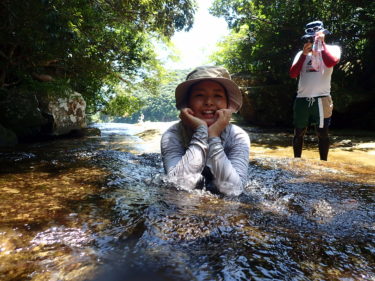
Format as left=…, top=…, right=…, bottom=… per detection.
left=161, top=66, right=250, bottom=196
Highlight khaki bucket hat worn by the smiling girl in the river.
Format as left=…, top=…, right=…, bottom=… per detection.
left=175, top=66, right=242, bottom=112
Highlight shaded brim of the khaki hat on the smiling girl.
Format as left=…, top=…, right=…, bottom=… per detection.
left=175, top=77, right=242, bottom=112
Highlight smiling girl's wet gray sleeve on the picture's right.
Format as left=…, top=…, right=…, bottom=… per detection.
left=207, top=127, right=250, bottom=196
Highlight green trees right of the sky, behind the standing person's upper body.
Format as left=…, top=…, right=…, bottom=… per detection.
left=211, top=0, right=375, bottom=87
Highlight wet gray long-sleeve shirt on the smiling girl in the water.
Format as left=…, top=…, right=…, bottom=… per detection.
left=161, top=122, right=250, bottom=196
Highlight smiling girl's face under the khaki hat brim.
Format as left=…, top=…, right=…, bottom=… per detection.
left=188, top=80, right=228, bottom=126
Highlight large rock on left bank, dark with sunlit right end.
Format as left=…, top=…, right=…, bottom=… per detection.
left=0, top=89, right=87, bottom=147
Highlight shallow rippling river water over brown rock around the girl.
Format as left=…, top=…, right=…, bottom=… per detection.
left=0, top=124, right=375, bottom=281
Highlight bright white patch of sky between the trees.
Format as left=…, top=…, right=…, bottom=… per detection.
left=159, top=0, right=229, bottom=69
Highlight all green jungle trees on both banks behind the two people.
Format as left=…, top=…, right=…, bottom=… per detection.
left=0, top=0, right=375, bottom=128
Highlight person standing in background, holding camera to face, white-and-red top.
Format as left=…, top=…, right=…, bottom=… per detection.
left=289, top=21, right=341, bottom=161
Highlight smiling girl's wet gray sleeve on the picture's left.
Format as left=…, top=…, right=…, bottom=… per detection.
left=161, top=125, right=208, bottom=190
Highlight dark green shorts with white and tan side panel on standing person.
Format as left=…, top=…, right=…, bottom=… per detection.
left=293, top=96, right=333, bottom=128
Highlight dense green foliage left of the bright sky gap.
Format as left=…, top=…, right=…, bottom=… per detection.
left=0, top=0, right=195, bottom=112
